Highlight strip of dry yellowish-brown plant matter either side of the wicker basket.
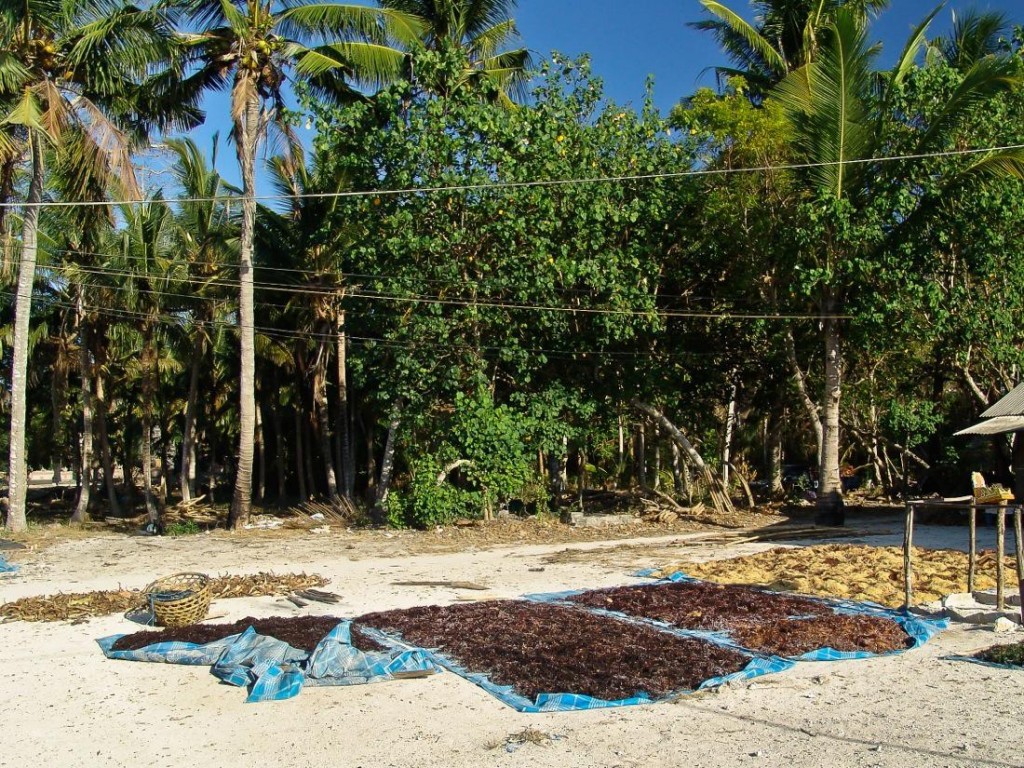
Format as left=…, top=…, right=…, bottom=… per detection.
left=0, top=573, right=327, bottom=622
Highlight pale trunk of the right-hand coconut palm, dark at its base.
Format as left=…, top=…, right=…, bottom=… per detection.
left=815, top=309, right=846, bottom=525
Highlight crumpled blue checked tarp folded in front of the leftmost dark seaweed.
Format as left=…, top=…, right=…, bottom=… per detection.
left=97, top=621, right=437, bottom=702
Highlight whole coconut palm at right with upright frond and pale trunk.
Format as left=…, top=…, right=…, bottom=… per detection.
left=768, top=8, right=1024, bottom=522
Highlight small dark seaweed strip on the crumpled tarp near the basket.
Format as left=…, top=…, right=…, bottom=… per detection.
left=113, top=616, right=386, bottom=653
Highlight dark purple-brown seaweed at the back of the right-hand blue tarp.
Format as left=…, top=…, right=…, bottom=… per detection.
left=568, top=582, right=831, bottom=631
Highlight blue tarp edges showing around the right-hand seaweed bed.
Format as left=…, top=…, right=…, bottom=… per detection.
left=526, top=570, right=949, bottom=662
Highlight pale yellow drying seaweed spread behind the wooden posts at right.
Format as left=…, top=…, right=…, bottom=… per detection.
left=658, top=544, right=1017, bottom=607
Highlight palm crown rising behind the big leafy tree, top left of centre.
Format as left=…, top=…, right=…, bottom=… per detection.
left=380, top=0, right=531, bottom=105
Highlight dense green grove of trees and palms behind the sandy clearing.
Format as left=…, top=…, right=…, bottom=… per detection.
left=0, top=0, right=1024, bottom=527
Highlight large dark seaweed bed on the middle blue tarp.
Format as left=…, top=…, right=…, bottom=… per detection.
left=355, top=600, right=749, bottom=700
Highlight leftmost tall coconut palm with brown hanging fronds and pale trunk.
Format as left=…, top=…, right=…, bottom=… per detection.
left=0, top=0, right=186, bottom=529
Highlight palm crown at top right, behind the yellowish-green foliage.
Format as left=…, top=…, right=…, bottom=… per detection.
left=690, top=0, right=890, bottom=97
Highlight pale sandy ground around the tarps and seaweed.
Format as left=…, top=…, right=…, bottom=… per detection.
left=0, top=519, right=1024, bottom=768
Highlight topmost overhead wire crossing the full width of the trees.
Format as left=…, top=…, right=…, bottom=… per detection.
left=0, top=144, right=1024, bottom=208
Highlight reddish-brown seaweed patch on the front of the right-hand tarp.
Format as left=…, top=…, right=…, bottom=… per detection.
left=731, top=614, right=913, bottom=656
